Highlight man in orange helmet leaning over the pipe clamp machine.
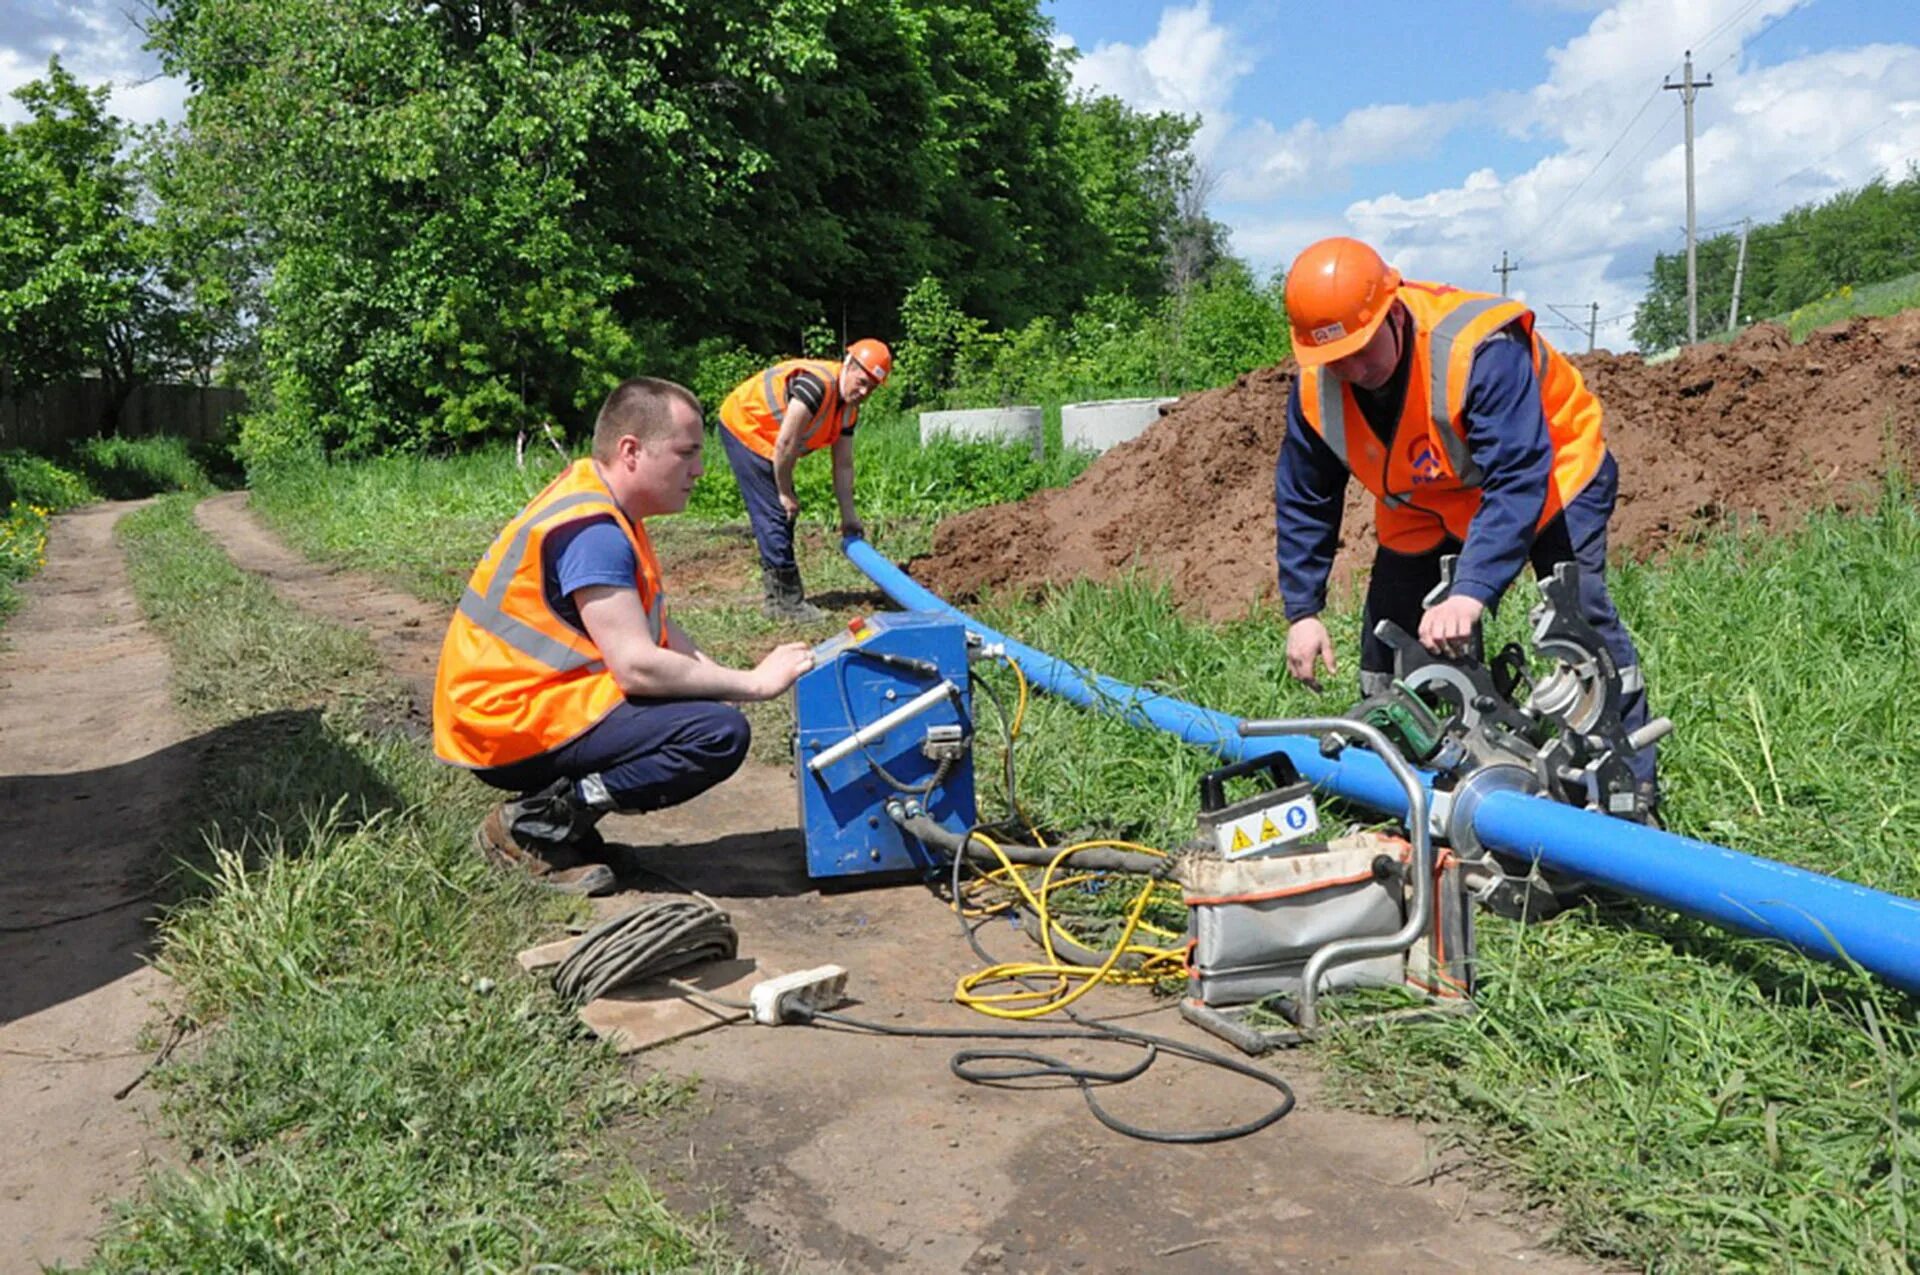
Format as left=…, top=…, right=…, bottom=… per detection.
left=1273, top=238, right=1659, bottom=812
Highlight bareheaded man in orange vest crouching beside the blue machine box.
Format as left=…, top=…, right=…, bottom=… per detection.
left=434, top=376, right=812, bottom=895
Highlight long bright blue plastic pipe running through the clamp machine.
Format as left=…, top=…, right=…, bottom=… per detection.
left=843, top=540, right=1920, bottom=993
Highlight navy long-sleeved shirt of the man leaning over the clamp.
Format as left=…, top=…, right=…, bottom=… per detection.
left=1273, top=318, right=1553, bottom=620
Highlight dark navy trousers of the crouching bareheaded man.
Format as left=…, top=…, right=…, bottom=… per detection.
left=474, top=699, right=753, bottom=812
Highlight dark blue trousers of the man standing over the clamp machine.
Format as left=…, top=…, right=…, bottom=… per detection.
left=1359, top=455, right=1657, bottom=783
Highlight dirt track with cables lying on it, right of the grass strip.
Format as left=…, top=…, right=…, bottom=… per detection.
left=202, top=497, right=1592, bottom=1271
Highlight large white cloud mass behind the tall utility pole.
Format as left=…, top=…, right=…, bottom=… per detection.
left=1223, top=0, right=1920, bottom=348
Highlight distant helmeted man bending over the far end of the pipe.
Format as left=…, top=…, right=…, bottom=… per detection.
left=720, top=338, right=893, bottom=622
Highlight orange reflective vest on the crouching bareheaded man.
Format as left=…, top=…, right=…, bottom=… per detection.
left=434, top=461, right=666, bottom=768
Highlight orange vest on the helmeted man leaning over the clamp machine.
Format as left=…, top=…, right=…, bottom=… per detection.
left=1300, top=280, right=1607, bottom=553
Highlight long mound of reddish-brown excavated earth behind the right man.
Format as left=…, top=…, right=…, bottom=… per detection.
left=910, top=311, right=1920, bottom=620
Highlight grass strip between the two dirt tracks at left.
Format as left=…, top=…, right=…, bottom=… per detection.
left=94, top=497, right=737, bottom=1271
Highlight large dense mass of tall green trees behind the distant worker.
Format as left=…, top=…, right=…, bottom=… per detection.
left=150, top=0, right=1213, bottom=451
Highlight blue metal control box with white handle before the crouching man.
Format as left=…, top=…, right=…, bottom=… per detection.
left=793, top=611, right=975, bottom=878
